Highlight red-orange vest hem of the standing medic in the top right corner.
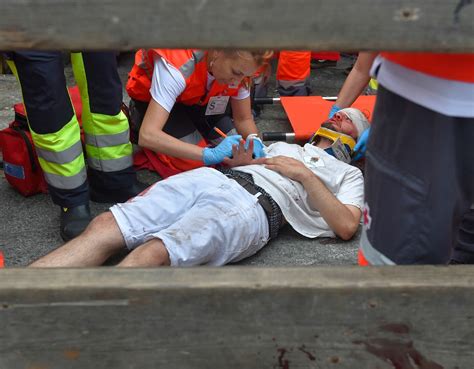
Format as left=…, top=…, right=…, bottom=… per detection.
left=382, top=52, right=474, bottom=83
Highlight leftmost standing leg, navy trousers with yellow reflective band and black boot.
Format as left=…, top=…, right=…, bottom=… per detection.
left=7, top=51, right=91, bottom=240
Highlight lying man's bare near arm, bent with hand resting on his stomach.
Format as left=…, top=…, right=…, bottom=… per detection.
left=256, top=156, right=361, bottom=240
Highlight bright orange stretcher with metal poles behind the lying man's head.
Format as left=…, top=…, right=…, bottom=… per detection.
left=255, top=95, right=376, bottom=142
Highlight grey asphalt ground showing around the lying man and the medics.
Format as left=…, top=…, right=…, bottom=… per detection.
left=0, top=54, right=360, bottom=266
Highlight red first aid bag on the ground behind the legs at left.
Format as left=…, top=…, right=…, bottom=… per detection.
left=0, top=87, right=82, bottom=196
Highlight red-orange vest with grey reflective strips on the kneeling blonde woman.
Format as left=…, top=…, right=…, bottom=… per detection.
left=126, top=49, right=240, bottom=105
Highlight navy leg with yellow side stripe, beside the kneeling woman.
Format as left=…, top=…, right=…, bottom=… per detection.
left=71, top=52, right=146, bottom=202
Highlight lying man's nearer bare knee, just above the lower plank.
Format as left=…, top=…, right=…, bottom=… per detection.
left=117, top=238, right=171, bottom=267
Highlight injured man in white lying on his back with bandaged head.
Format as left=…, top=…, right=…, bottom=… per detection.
left=31, top=108, right=369, bottom=267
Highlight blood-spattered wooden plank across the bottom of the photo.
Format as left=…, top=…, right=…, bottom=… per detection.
left=0, top=266, right=474, bottom=369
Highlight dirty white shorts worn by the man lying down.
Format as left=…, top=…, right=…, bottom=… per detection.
left=110, top=168, right=269, bottom=266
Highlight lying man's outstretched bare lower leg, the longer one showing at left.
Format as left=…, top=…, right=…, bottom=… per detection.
left=30, top=212, right=125, bottom=268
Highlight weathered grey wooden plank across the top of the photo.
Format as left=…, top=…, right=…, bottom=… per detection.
left=0, top=0, right=474, bottom=52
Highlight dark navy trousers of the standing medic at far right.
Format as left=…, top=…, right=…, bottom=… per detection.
left=360, top=86, right=468, bottom=264
